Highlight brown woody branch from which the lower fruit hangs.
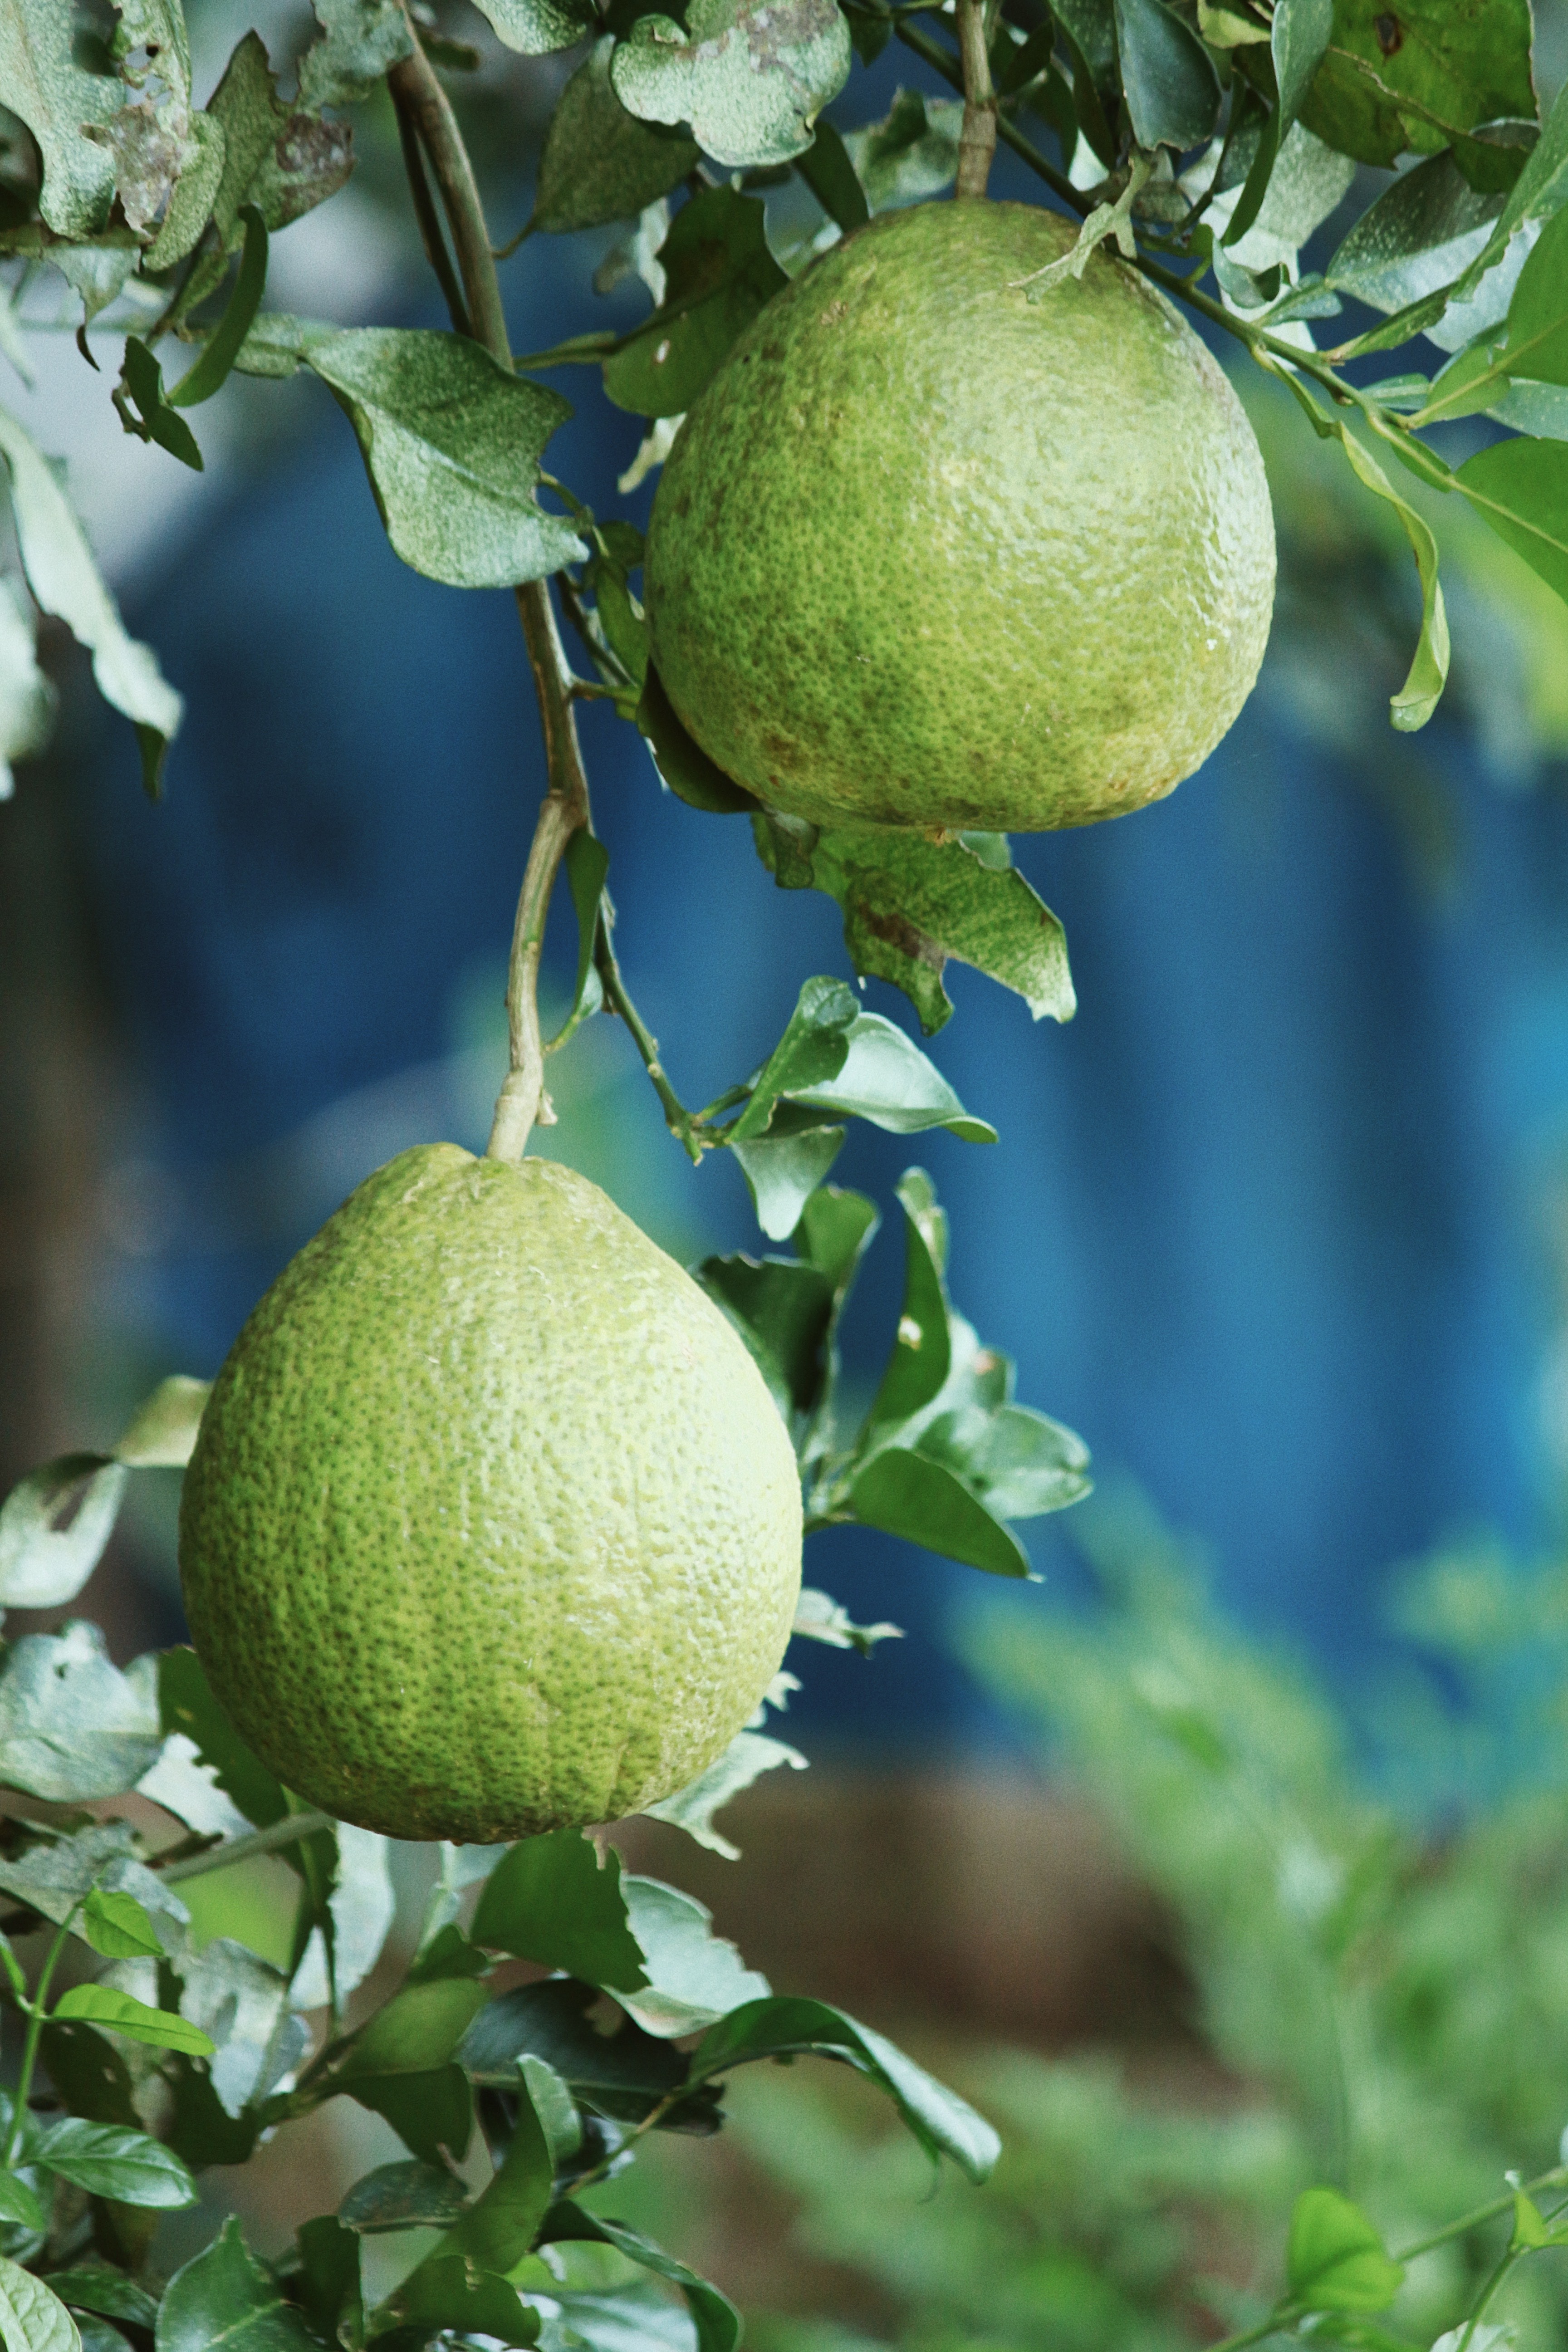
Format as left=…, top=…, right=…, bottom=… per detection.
left=388, top=0, right=588, bottom=1160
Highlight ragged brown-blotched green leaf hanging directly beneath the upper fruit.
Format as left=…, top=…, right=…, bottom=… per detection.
left=752, top=813, right=1077, bottom=1037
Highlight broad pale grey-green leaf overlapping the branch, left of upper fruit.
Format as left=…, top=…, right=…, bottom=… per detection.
left=306, top=327, right=588, bottom=588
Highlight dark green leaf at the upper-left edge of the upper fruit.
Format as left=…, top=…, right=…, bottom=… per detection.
left=604, top=188, right=789, bottom=423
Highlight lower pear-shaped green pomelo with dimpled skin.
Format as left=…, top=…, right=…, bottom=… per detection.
left=179, top=1143, right=802, bottom=1844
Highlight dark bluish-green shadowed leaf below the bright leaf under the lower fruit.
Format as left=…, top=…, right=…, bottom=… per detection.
left=458, top=1976, right=686, bottom=2124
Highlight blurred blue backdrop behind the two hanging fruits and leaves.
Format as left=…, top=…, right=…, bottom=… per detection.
left=0, top=12, right=1568, bottom=1752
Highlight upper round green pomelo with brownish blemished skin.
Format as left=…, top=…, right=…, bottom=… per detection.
left=647, top=202, right=1274, bottom=833
